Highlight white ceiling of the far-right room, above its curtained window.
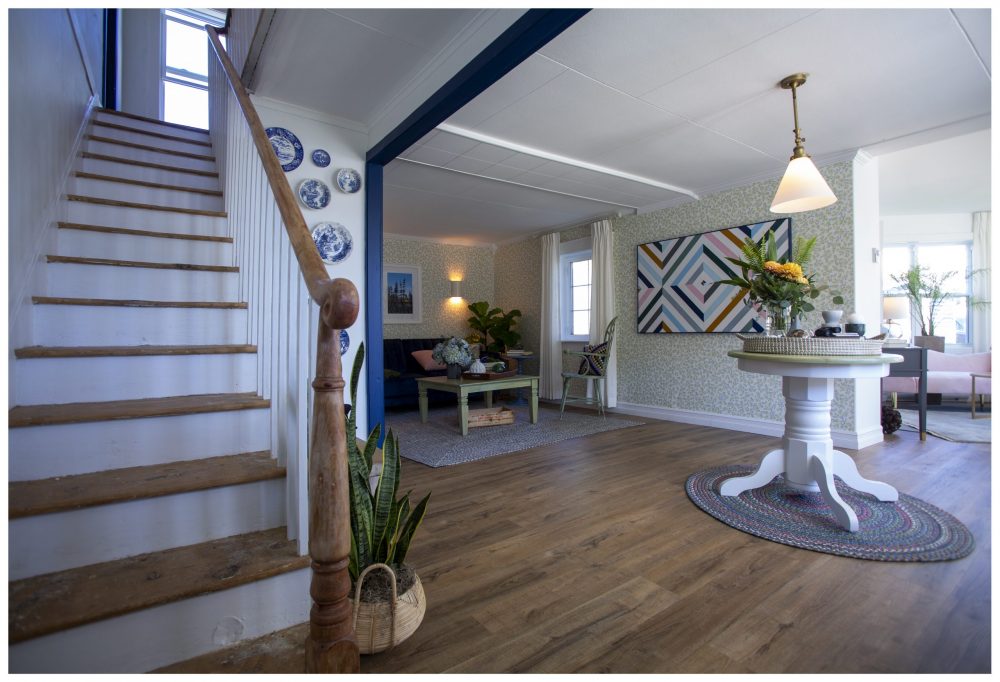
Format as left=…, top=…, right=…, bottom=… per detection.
left=878, top=130, right=991, bottom=215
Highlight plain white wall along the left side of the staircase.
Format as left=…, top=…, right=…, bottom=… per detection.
left=7, top=9, right=95, bottom=404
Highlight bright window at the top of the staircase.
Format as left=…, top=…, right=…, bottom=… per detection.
left=160, top=9, right=226, bottom=128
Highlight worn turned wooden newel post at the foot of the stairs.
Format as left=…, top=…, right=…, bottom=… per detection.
left=306, top=279, right=361, bottom=673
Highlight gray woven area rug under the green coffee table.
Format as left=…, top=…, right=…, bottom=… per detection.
left=386, top=403, right=644, bottom=467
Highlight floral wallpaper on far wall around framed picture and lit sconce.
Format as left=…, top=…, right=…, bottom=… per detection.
left=380, top=238, right=494, bottom=339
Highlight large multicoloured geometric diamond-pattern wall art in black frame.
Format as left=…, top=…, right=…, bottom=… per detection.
left=636, top=218, right=792, bottom=334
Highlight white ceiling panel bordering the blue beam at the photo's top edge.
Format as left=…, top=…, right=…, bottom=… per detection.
left=540, top=9, right=816, bottom=96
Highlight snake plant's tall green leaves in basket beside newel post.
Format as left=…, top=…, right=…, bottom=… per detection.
left=346, top=343, right=431, bottom=581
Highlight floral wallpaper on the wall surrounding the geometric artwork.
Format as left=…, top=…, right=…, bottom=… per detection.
left=613, top=162, right=854, bottom=430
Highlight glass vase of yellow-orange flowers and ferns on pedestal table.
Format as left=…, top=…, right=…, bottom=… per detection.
left=721, top=232, right=844, bottom=336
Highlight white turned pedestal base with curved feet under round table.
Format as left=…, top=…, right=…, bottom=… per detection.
left=719, top=376, right=899, bottom=532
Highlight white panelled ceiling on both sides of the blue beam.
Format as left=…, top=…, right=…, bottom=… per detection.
left=252, top=9, right=991, bottom=243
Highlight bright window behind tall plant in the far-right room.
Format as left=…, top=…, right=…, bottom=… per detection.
left=882, top=242, right=972, bottom=346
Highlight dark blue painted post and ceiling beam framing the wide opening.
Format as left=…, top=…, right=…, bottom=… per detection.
left=364, top=9, right=590, bottom=431
